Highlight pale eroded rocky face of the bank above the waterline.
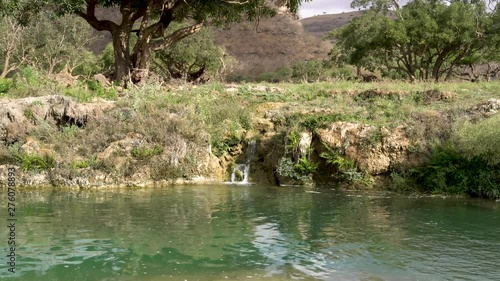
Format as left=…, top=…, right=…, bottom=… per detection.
left=0, top=91, right=500, bottom=188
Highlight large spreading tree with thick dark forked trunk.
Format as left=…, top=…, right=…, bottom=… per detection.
left=0, top=0, right=308, bottom=82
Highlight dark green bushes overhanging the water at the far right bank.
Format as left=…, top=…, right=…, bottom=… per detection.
left=391, top=114, right=500, bottom=198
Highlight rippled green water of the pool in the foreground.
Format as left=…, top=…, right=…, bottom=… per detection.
left=0, top=186, right=500, bottom=281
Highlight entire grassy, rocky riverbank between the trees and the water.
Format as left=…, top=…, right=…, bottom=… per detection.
left=0, top=77, right=500, bottom=198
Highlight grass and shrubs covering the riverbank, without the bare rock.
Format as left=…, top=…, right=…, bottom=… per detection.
left=0, top=70, right=500, bottom=198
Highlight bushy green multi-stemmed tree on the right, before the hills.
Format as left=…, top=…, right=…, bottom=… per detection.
left=331, top=0, right=493, bottom=81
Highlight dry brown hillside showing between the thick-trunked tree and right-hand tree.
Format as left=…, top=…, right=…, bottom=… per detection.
left=212, top=14, right=331, bottom=76
